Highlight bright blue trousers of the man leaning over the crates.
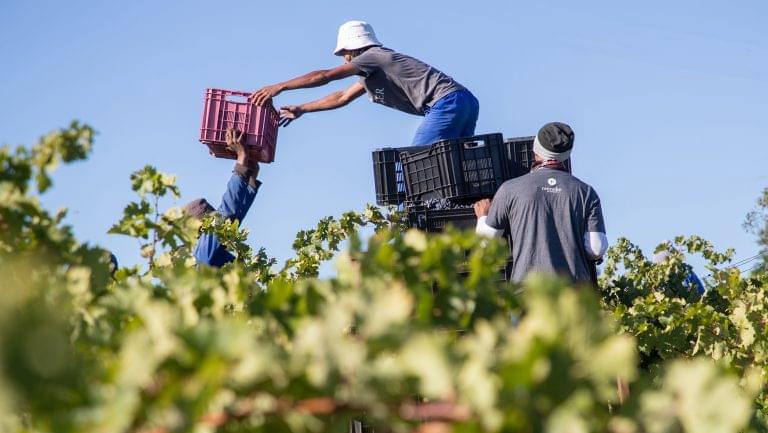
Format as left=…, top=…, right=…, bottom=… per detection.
left=413, top=89, right=480, bottom=146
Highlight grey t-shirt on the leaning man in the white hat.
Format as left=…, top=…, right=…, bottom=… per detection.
left=352, top=47, right=464, bottom=116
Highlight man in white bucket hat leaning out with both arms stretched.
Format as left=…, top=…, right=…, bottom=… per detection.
left=249, top=21, right=480, bottom=145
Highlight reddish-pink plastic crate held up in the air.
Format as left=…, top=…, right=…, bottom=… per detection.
left=200, top=89, right=280, bottom=162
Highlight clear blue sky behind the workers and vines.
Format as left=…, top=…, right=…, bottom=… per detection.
left=0, top=0, right=768, bottom=274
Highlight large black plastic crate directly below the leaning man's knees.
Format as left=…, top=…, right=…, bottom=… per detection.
left=400, top=134, right=509, bottom=202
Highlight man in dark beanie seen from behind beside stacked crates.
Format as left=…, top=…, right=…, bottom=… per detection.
left=475, top=123, right=608, bottom=282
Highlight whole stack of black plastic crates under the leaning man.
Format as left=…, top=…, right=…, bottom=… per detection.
left=373, top=133, right=570, bottom=277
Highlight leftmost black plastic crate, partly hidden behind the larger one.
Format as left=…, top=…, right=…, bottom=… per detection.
left=372, top=146, right=429, bottom=206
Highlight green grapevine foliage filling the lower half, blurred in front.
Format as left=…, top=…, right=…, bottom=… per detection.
left=0, top=123, right=768, bottom=433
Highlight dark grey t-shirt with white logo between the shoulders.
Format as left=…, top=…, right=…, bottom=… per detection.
left=486, top=168, right=605, bottom=282
